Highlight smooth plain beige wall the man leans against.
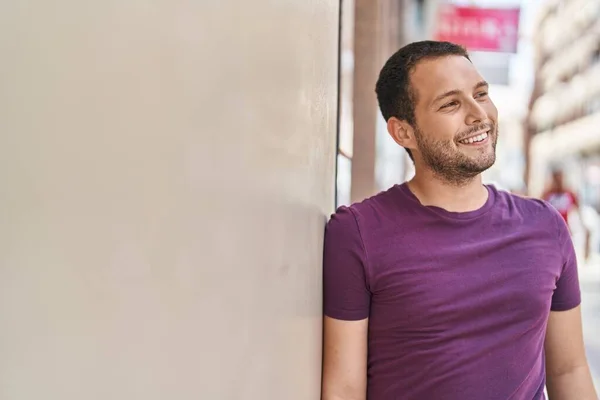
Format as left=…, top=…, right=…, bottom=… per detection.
left=0, top=0, right=339, bottom=400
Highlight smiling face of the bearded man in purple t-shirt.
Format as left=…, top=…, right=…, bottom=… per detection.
left=411, top=56, right=498, bottom=183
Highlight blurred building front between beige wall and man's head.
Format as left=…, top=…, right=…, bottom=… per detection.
left=337, top=0, right=439, bottom=205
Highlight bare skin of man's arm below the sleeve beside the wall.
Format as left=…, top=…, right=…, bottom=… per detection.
left=322, top=317, right=368, bottom=400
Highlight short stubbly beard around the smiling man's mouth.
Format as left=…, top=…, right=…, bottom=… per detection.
left=415, top=123, right=498, bottom=186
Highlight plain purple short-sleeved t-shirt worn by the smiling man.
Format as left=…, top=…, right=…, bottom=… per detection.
left=324, top=184, right=581, bottom=400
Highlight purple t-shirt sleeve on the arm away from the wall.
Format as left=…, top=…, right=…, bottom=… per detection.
left=551, top=209, right=581, bottom=311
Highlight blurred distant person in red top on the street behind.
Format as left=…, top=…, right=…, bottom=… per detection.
left=542, top=168, right=590, bottom=259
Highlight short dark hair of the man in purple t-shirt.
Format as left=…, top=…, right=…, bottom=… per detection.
left=375, top=40, right=471, bottom=160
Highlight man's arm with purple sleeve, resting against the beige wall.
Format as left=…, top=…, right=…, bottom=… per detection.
left=323, top=207, right=371, bottom=400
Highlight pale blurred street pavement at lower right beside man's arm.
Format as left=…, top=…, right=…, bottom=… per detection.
left=579, top=261, right=600, bottom=391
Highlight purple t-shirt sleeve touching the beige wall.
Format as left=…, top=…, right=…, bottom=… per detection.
left=323, top=207, right=371, bottom=321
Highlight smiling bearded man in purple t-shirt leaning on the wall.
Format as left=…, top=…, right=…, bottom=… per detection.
left=322, top=41, right=597, bottom=400
